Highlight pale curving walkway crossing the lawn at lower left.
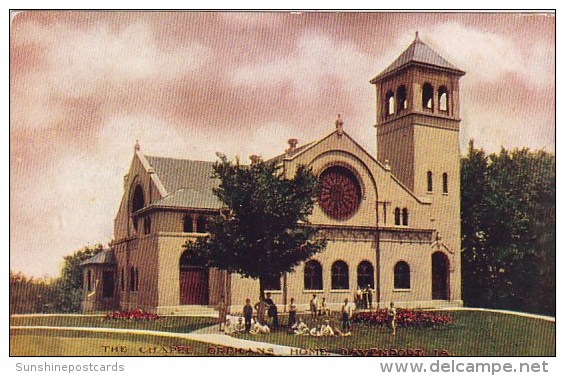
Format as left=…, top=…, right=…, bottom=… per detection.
left=10, top=325, right=322, bottom=356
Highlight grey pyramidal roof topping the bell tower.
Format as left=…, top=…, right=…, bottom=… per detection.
left=371, top=32, right=465, bottom=83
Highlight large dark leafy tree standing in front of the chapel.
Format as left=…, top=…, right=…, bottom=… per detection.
left=186, top=154, right=326, bottom=298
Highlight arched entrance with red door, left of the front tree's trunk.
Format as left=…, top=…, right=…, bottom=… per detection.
left=179, top=251, right=208, bottom=305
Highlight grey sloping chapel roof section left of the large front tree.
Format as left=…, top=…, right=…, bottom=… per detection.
left=145, top=156, right=222, bottom=209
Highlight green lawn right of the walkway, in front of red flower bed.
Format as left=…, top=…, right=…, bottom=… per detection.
left=235, top=311, right=555, bottom=356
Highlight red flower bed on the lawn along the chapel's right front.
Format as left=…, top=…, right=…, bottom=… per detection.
left=351, top=309, right=453, bottom=328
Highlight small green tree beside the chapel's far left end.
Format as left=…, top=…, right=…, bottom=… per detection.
left=54, top=244, right=104, bottom=312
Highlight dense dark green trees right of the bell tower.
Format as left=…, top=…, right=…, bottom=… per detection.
left=461, top=142, right=556, bottom=314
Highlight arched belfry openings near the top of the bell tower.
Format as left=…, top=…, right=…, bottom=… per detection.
left=385, top=82, right=449, bottom=116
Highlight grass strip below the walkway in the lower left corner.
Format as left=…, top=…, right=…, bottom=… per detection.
left=10, top=329, right=254, bottom=356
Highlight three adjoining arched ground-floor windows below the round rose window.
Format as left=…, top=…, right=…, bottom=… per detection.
left=304, top=260, right=375, bottom=290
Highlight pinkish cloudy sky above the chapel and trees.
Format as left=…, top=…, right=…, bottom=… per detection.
left=10, top=12, right=555, bottom=276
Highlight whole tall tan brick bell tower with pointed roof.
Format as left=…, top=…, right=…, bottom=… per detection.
left=371, top=32, right=465, bottom=301
